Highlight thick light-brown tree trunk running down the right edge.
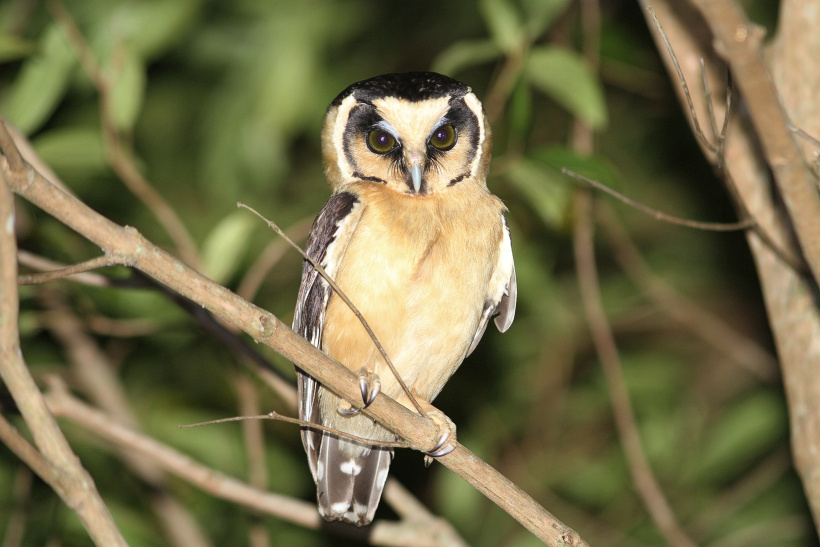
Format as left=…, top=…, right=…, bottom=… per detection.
left=642, top=0, right=820, bottom=526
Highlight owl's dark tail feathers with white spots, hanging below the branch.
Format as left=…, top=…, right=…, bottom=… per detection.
left=316, top=434, right=393, bottom=526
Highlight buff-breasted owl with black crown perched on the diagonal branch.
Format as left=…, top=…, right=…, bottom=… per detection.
left=293, top=72, right=516, bottom=526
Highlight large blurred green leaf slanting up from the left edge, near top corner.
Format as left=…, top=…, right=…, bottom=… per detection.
left=0, top=25, right=77, bottom=135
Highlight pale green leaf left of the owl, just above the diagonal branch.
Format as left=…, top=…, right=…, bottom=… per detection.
left=202, top=211, right=259, bottom=284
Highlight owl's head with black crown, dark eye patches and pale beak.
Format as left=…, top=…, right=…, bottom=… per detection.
left=322, top=72, right=492, bottom=197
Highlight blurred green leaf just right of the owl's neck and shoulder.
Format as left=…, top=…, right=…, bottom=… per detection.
left=505, top=159, right=570, bottom=229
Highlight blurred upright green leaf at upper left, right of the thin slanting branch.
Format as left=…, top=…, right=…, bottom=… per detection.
left=106, top=47, right=145, bottom=130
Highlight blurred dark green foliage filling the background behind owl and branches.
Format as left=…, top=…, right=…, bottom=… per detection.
left=0, top=0, right=816, bottom=546
